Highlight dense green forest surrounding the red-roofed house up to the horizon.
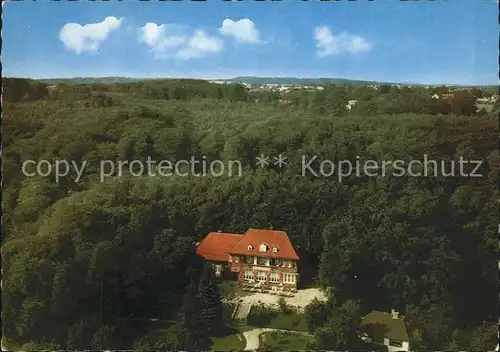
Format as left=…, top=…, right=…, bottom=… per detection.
left=2, top=78, right=500, bottom=351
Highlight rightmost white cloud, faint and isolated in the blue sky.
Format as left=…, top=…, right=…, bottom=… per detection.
left=314, top=26, right=372, bottom=57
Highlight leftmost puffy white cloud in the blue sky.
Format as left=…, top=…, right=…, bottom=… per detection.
left=59, top=16, right=122, bottom=54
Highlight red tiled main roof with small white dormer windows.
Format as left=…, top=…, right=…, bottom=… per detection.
left=229, top=229, right=299, bottom=260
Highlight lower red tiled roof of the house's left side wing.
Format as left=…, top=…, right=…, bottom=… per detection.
left=196, top=232, right=243, bottom=262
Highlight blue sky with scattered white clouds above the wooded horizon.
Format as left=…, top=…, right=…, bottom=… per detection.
left=2, top=0, right=499, bottom=85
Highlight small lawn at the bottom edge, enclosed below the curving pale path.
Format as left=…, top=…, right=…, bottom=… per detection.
left=259, top=331, right=314, bottom=351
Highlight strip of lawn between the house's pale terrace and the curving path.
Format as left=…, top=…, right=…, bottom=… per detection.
left=247, top=307, right=308, bottom=332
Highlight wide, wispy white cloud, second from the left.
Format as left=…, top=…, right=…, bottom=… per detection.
left=139, top=23, right=224, bottom=60
